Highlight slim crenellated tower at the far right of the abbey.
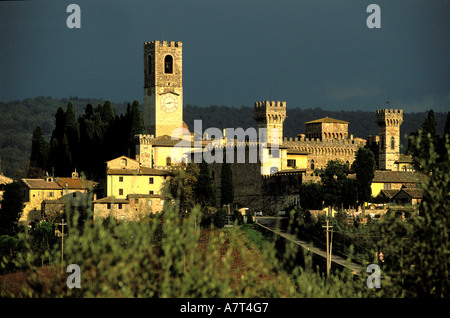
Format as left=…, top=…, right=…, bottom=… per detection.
left=375, top=109, right=403, bottom=170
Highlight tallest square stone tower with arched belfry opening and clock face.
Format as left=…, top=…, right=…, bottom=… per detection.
left=144, top=41, right=183, bottom=137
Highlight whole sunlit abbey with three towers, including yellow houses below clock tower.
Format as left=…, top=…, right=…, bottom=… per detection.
left=90, top=41, right=403, bottom=219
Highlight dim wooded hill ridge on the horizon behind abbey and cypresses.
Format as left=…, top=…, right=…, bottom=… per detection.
left=0, top=97, right=447, bottom=178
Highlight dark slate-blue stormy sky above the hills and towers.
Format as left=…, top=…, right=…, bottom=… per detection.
left=0, top=0, right=450, bottom=112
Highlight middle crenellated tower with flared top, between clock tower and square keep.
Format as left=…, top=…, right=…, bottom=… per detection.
left=253, top=101, right=286, bottom=145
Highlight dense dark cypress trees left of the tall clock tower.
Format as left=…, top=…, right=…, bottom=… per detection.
left=27, top=101, right=146, bottom=180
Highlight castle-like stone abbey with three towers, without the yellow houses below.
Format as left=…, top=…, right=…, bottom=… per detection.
left=127, top=41, right=403, bottom=211
